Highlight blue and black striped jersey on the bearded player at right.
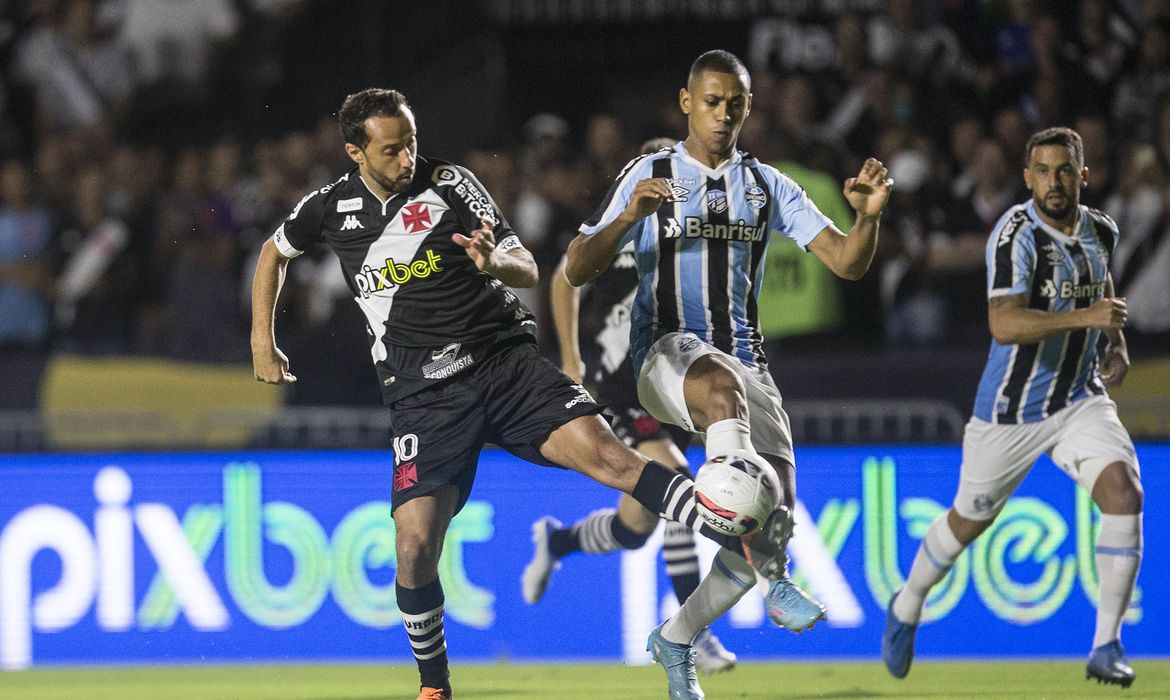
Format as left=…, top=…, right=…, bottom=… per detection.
left=975, top=201, right=1117, bottom=424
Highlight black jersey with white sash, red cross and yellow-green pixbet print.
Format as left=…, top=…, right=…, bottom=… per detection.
left=273, top=157, right=536, bottom=405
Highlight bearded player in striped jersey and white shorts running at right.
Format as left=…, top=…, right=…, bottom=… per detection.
left=882, top=126, right=1143, bottom=687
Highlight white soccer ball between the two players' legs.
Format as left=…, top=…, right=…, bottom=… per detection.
left=695, top=455, right=780, bottom=535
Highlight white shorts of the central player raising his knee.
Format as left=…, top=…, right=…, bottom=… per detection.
left=638, top=332, right=796, bottom=465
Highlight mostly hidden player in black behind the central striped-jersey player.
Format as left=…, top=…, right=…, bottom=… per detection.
left=521, top=138, right=736, bottom=673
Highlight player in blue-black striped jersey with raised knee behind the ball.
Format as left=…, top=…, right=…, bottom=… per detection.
left=565, top=50, right=892, bottom=698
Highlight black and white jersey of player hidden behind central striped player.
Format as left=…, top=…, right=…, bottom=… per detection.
left=579, top=246, right=638, bottom=393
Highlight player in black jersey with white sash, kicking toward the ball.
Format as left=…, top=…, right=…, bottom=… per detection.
left=252, top=89, right=784, bottom=700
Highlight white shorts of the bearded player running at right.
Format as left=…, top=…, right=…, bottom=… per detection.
left=955, top=396, right=1141, bottom=520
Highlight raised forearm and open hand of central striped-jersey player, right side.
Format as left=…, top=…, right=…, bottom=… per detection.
left=808, top=158, right=894, bottom=280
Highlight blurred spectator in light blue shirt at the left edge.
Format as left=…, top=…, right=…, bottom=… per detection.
left=0, top=160, right=54, bottom=409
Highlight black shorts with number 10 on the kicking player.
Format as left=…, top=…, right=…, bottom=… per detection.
left=390, top=343, right=601, bottom=513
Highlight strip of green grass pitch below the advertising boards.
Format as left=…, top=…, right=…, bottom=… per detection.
left=0, top=659, right=1170, bottom=700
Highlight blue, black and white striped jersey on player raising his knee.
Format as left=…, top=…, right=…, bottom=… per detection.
left=580, top=142, right=830, bottom=372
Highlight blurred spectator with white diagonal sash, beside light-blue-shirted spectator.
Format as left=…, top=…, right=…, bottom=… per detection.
left=54, top=165, right=134, bottom=354
